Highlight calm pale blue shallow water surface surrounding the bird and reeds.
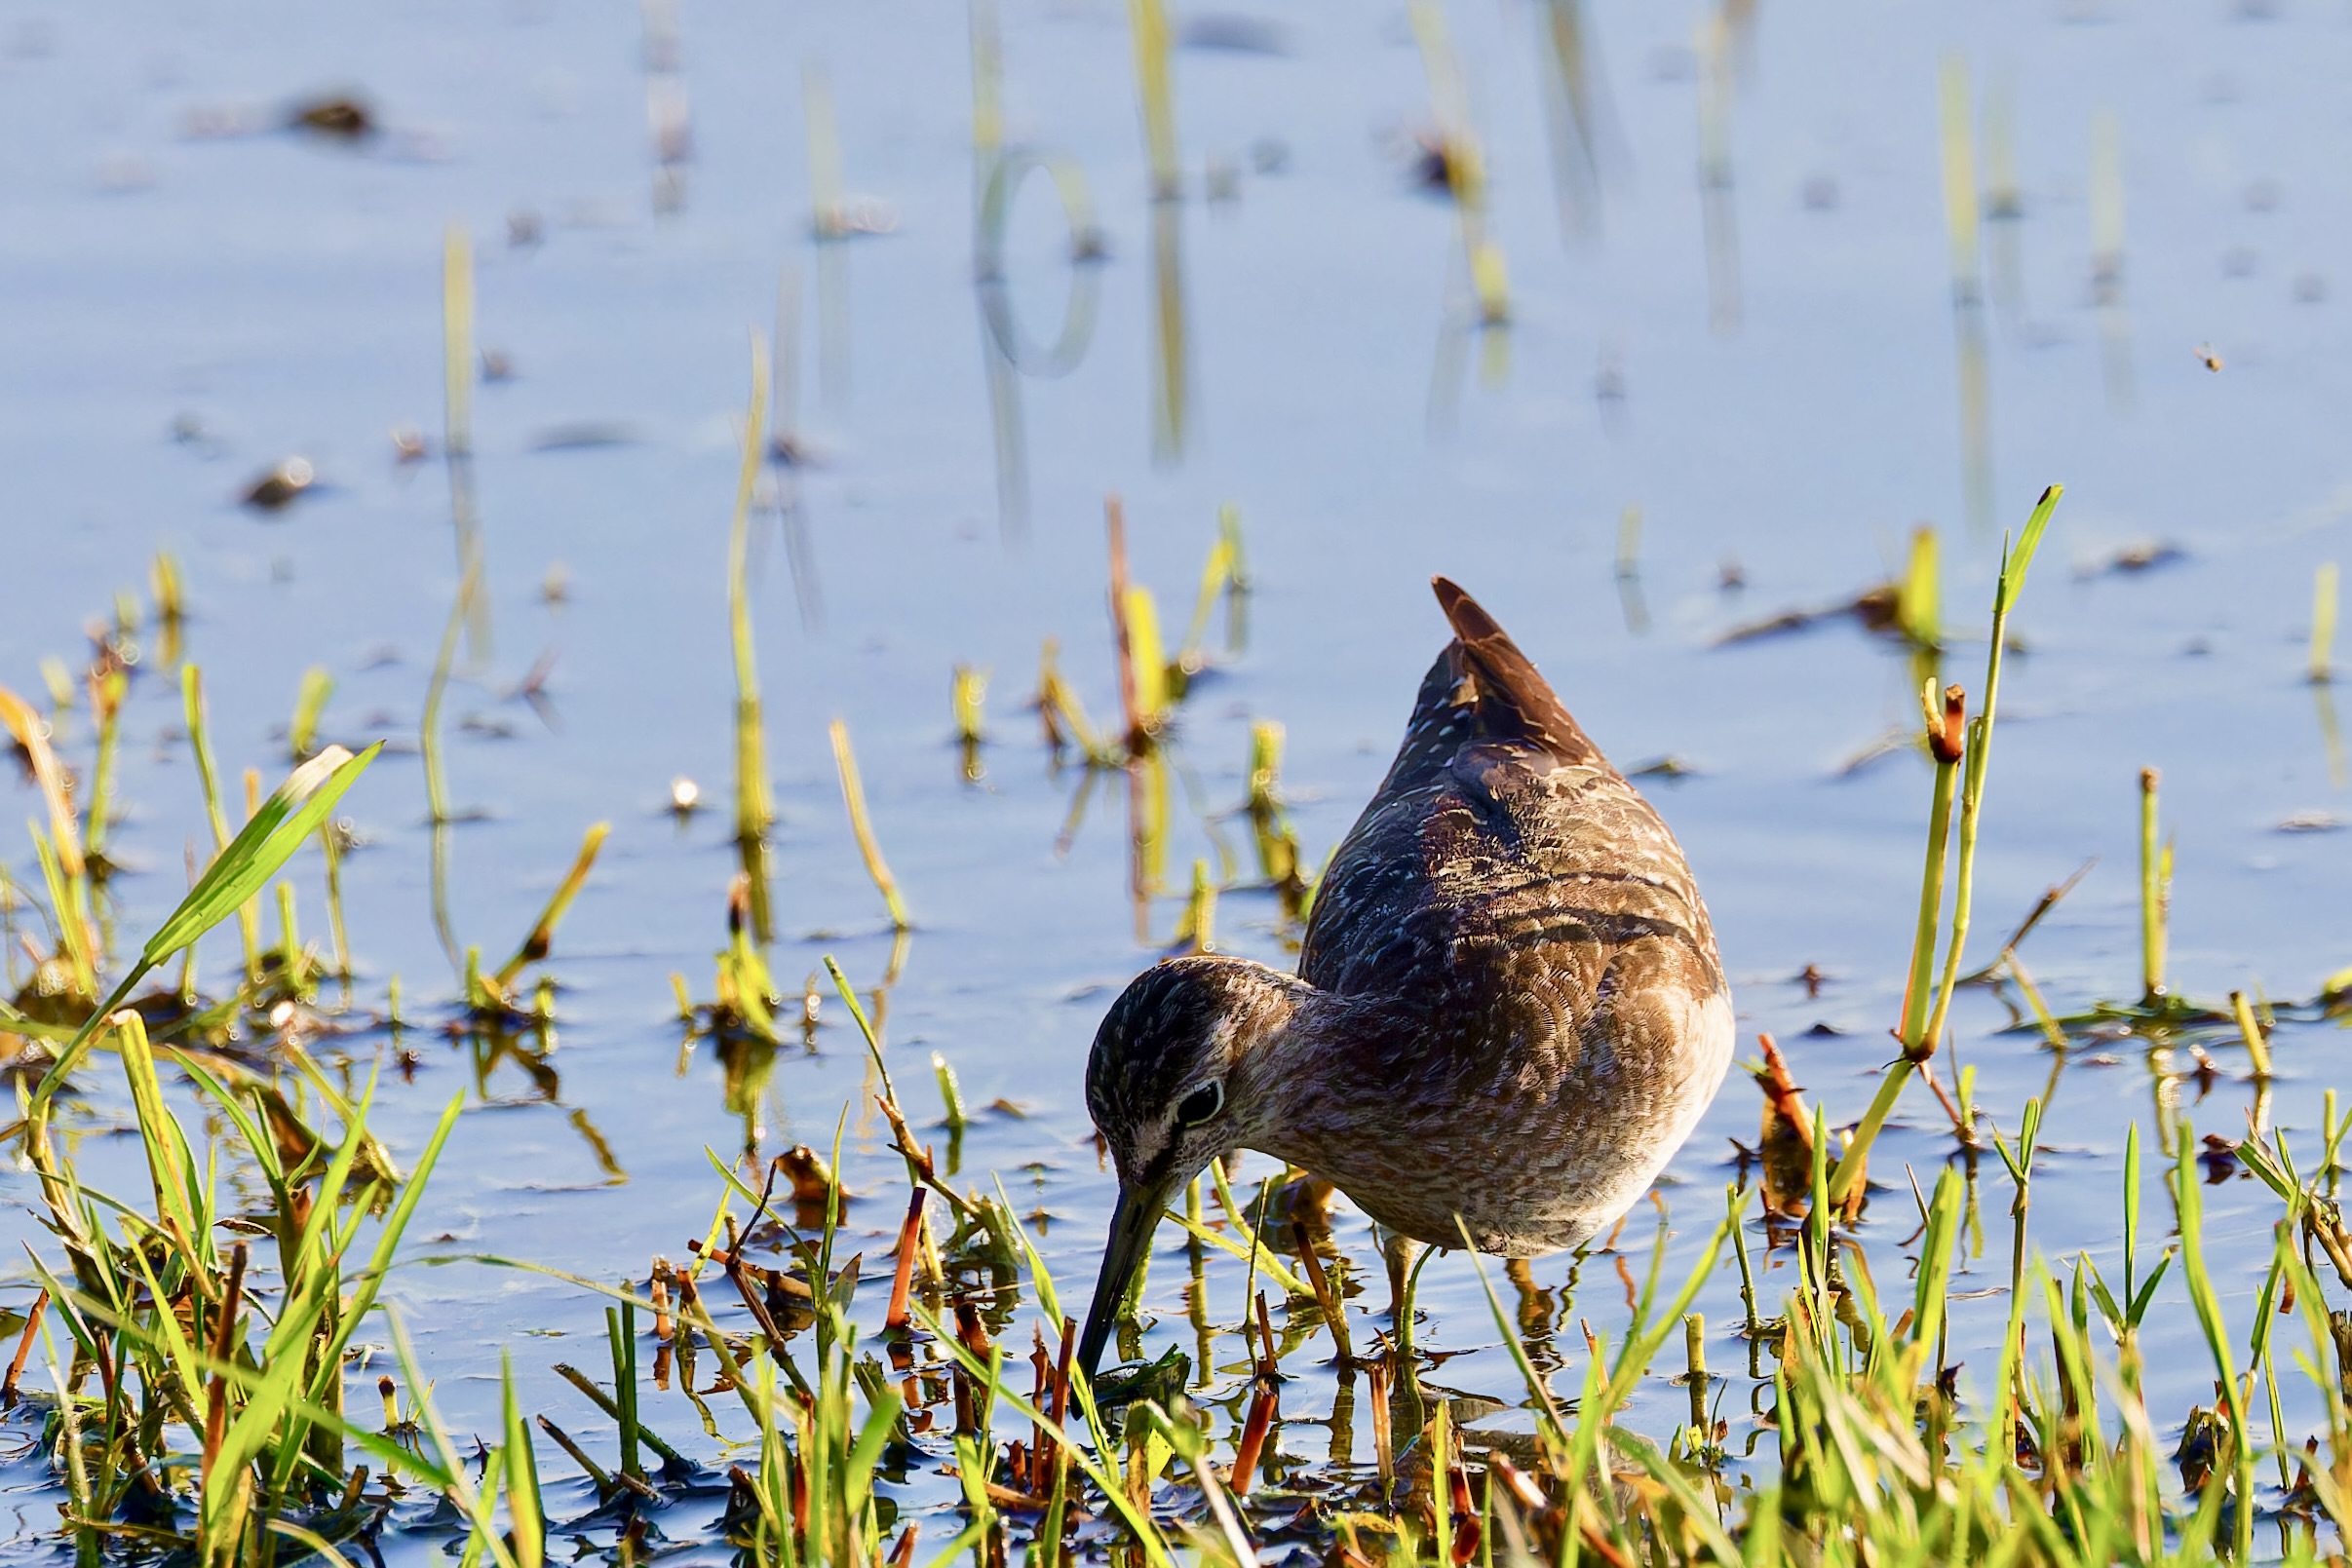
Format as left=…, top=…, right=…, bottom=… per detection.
left=0, top=2, right=2352, bottom=1556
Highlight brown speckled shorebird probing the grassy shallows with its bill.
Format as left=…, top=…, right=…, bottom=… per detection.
left=1077, top=578, right=1733, bottom=1375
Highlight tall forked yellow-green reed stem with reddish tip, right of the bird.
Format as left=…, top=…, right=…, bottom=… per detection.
left=1832, top=484, right=2065, bottom=1204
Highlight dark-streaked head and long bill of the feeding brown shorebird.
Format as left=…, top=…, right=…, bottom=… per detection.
left=1077, top=957, right=1310, bottom=1378
